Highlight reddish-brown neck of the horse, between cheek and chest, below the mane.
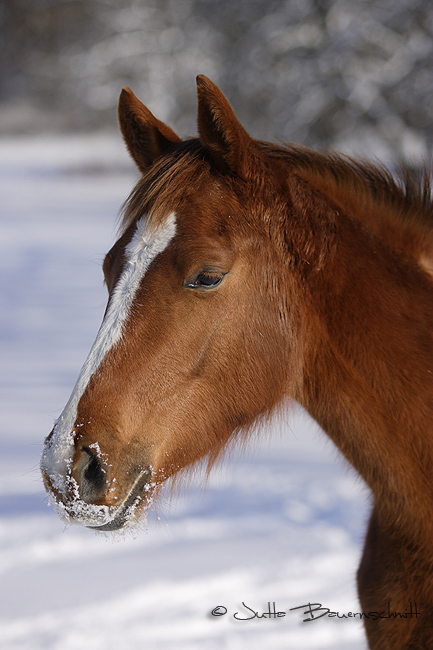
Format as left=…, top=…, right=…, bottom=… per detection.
left=300, top=217, right=433, bottom=544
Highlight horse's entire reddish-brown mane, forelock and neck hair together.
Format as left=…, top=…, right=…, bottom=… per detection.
left=120, top=139, right=433, bottom=275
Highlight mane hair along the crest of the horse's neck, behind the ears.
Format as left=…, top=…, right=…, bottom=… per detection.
left=260, top=142, right=433, bottom=273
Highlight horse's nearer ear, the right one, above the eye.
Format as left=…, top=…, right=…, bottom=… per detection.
left=197, top=75, right=254, bottom=177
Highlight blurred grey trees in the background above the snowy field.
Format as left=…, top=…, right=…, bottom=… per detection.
left=0, top=0, right=433, bottom=157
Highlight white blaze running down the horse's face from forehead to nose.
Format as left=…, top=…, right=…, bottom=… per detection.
left=41, top=213, right=176, bottom=493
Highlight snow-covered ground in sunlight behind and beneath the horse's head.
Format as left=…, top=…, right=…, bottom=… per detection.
left=0, top=137, right=368, bottom=650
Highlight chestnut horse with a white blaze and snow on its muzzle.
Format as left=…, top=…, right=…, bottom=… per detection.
left=42, top=76, right=433, bottom=650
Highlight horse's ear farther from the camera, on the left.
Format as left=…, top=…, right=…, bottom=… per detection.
left=118, top=88, right=180, bottom=172
